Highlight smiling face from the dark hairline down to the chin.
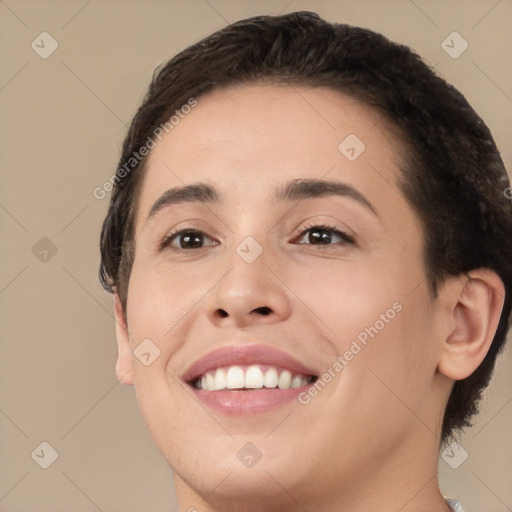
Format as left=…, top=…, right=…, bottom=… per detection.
left=118, top=85, right=444, bottom=506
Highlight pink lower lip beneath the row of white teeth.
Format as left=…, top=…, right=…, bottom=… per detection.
left=190, top=384, right=311, bottom=416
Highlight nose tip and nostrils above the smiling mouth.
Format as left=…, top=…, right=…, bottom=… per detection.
left=208, top=247, right=291, bottom=328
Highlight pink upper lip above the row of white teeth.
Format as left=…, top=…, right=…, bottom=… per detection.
left=183, top=345, right=318, bottom=382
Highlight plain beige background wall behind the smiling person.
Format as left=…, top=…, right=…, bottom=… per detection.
left=0, top=0, right=512, bottom=512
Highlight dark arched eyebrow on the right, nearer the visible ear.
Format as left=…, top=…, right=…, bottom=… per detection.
left=274, top=179, right=379, bottom=217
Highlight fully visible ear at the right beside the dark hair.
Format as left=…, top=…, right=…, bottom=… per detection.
left=438, top=269, right=505, bottom=380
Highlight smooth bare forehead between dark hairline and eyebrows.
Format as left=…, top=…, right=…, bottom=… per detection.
left=136, top=84, right=410, bottom=234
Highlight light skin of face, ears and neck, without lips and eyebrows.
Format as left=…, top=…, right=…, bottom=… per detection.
left=115, top=84, right=504, bottom=512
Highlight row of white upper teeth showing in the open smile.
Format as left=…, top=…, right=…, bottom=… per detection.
left=196, top=364, right=310, bottom=391
